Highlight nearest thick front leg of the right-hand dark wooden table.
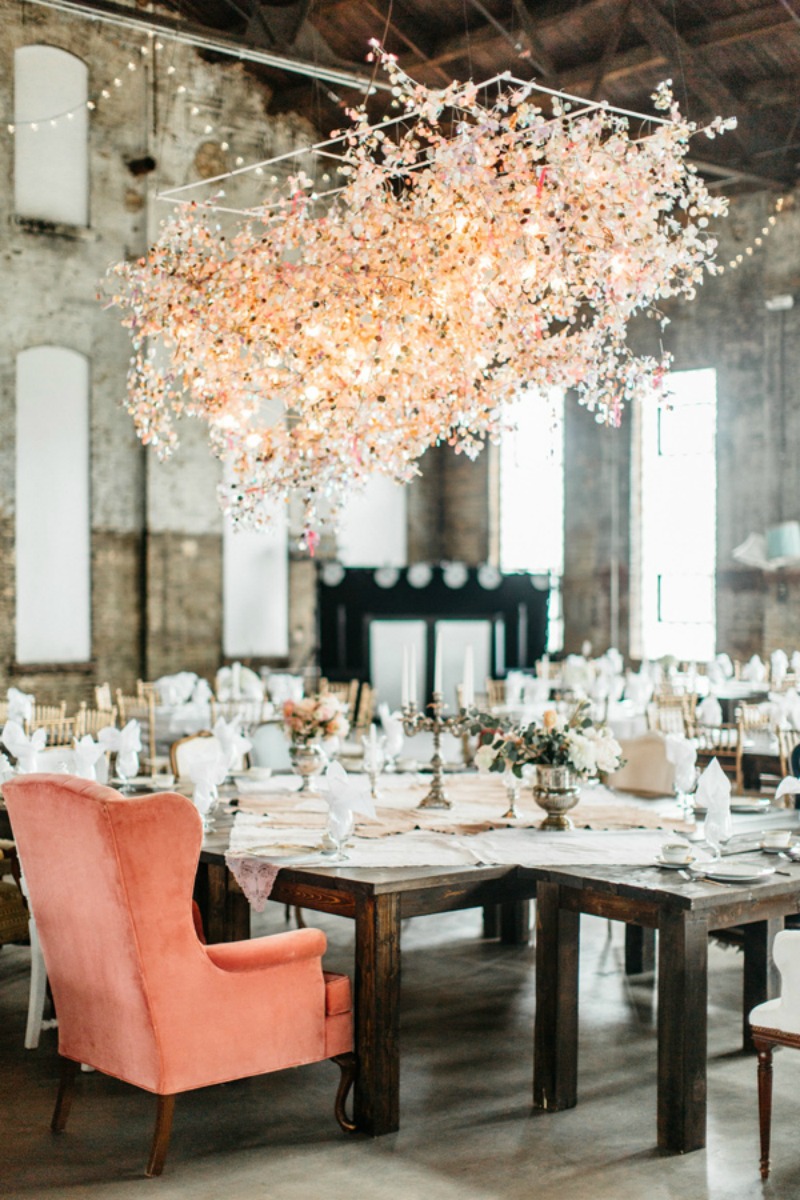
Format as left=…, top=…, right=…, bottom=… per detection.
left=657, top=912, right=708, bottom=1153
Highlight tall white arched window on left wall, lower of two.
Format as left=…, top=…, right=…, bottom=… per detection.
left=16, top=346, right=91, bottom=662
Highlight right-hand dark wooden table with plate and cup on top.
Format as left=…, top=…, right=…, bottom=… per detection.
left=521, top=854, right=800, bottom=1152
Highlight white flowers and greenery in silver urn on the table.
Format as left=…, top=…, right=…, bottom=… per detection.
left=474, top=701, right=622, bottom=829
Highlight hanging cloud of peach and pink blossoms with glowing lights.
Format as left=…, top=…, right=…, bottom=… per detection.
left=106, top=48, right=734, bottom=535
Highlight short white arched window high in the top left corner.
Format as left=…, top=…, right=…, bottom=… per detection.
left=14, top=46, right=89, bottom=226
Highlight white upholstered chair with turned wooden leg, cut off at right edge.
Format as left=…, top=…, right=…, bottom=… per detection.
left=750, top=929, right=800, bottom=1180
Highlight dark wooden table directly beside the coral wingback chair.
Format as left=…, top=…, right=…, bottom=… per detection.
left=197, top=835, right=535, bottom=1136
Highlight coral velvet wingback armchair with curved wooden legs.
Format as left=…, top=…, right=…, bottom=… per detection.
left=2, top=775, right=355, bottom=1175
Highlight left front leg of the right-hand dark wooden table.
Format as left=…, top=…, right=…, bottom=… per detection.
left=534, top=883, right=581, bottom=1112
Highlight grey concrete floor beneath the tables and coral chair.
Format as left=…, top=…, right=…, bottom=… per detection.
left=0, top=906, right=800, bottom=1200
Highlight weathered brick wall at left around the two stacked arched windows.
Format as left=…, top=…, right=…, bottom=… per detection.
left=0, top=6, right=314, bottom=702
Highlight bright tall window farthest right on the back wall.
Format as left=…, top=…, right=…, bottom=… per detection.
left=632, top=370, right=716, bottom=660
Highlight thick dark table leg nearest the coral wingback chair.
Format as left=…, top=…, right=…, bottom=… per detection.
left=354, top=894, right=401, bottom=1136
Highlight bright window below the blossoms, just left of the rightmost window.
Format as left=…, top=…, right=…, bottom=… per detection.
left=500, top=389, right=564, bottom=650
